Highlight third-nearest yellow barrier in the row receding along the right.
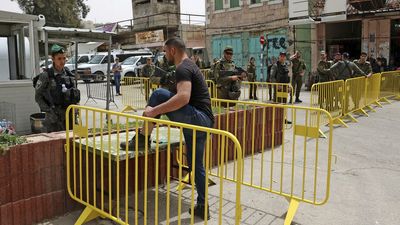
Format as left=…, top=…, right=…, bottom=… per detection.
left=365, top=73, right=382, bottom=111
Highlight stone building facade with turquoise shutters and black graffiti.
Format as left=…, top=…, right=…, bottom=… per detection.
left=206, top=0, right=296, bottom=81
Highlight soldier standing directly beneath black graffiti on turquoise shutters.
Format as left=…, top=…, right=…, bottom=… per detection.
left=271, top=52, right=290, bottom=103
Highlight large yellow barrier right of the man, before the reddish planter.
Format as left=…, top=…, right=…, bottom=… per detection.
left=212, top=99, right=333, bottom=225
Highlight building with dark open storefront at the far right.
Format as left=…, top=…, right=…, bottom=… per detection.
left=306, top=0, right=400, bottom=70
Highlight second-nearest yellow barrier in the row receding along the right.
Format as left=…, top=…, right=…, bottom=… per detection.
left=343, top=77, right=368, bottom=122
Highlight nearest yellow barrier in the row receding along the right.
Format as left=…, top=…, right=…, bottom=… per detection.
left=311, top=80, right=348, bottom=127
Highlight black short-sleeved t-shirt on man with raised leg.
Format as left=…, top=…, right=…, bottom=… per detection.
left=175, top=59, right=214, bottom=122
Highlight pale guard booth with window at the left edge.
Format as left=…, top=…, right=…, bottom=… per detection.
left=0, top=11, right=45, bottom=134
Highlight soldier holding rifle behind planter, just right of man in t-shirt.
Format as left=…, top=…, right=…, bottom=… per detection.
left=213, top=46, right=247, bottom=106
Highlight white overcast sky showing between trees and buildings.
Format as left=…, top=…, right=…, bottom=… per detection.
left=0, top=0, right=205, bottom=23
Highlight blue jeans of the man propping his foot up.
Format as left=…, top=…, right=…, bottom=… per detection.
left=148, top=88, right=213, bottom=205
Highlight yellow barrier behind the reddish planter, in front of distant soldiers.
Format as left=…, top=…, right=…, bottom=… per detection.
left=239, top=81, right=293, bottom=104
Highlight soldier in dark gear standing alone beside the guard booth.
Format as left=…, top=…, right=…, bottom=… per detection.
left=34, top=45, right=80, bottom=132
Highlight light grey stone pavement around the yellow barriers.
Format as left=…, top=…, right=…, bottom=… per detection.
left=43, top=85, right=400, bottom=225
